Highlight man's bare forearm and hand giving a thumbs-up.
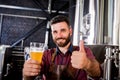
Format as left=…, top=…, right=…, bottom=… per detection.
left=71, top=41, right=101, bottom=77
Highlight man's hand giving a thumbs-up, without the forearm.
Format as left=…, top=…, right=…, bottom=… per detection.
left=71, top=40, right=90, bottom=69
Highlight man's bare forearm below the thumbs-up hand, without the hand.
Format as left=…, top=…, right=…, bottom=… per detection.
left=85, top=59, right=101, bottom=77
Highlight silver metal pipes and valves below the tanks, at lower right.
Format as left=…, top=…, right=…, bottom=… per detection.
left=103, top=45, right=120, bottom=80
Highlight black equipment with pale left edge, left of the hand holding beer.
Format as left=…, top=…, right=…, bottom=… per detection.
left=0, top=45, right=24, bottom=80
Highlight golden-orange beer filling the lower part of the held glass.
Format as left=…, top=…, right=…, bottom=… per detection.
left=30, top=51, right=43, bottom=63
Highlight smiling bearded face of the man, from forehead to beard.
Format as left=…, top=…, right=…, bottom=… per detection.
left=51, top=22, right=72, bottom=47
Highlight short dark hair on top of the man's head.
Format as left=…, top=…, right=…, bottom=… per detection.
left=50, top=15, right=70, bottom=26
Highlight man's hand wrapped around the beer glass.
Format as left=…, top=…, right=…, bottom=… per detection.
left=23, top=59, right=41, bottom=76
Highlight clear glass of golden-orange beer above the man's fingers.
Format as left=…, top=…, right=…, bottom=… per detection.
left=30, top=42, right=44, bottom=63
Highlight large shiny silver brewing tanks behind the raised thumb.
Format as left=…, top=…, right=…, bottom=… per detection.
left=73, top=0, right=120, bottom=45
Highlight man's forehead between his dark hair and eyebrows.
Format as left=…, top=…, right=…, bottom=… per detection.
left=51, top=22, right=69, bottom=30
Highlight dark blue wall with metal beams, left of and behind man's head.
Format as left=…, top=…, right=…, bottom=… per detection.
left=0, top=0, right=71, bottom=46
